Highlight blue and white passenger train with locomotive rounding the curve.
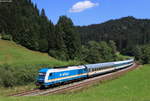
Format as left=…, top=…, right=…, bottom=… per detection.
left=36, top=58, right=134, bottom=88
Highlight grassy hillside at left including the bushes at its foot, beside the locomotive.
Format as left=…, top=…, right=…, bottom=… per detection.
left=0, top=40, right=82, bottom=87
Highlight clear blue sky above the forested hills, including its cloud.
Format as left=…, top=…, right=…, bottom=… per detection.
left=32, top=0, right=150, bottom=26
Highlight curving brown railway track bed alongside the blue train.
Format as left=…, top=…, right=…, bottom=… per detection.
left=9, top=64, right=139, bottom=96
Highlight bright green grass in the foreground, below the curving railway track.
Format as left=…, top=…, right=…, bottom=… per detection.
left=0, top=65, right=150, bottom=101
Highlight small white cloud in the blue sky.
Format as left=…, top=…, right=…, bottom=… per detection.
left=69, top=1, right=99, bottom=13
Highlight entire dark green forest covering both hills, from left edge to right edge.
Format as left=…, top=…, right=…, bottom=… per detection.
left=0, top=0, right=150, bottom=63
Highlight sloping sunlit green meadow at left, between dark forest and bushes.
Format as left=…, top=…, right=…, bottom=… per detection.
left=0, top=40, right=81, bottom=67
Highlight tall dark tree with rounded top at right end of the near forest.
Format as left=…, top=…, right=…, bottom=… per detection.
left=58, top=16, right=81, bottom=59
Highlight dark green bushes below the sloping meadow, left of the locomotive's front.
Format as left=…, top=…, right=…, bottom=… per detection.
left=0, top=65, right=39, bottom=87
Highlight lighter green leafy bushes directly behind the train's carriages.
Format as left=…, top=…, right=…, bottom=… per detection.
left=81, top=41, right=116, bottom=63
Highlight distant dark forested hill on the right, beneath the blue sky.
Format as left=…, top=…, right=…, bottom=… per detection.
left=77, top=16, right=150, bottom=55
